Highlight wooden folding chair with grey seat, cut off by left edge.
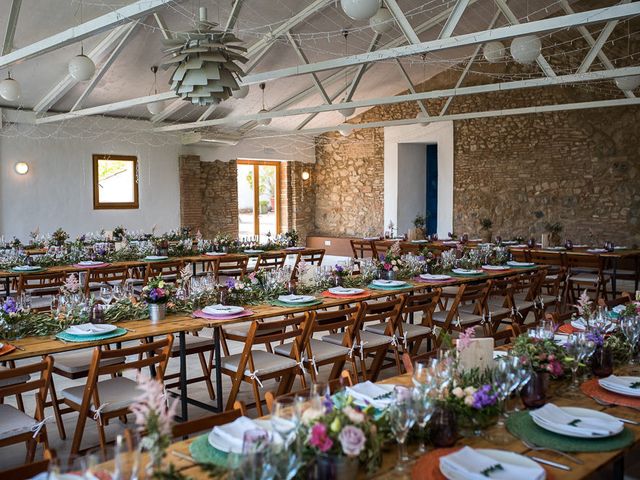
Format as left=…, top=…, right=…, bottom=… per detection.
left=0, top=357, right=53, bottom=462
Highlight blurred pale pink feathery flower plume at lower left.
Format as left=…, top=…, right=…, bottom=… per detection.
left=129, top=375, right=178, bottom=474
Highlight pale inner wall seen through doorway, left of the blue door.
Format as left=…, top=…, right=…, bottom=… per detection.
left=397, top=143, right=427, bottom=233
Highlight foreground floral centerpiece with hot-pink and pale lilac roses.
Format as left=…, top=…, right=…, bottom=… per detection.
left=300, top=396, right=384, bottom=478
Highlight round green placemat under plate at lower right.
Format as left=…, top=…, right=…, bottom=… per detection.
left=507, top=411, right=634, bottom=452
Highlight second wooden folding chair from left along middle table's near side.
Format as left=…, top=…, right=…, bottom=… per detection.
left=61, top=335, right=173, bottom=454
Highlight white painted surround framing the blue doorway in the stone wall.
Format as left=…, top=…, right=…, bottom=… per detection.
left=384, top=122, right=453, bottom=237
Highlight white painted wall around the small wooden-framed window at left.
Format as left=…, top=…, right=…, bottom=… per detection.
left=0, top=118, right=182, bottom=240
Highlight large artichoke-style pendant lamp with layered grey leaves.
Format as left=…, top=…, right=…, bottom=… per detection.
left=162, top=7, right=247, bottom=106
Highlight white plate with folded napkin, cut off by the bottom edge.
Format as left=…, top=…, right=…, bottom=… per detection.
left=440, top=447, right=546, bottom=480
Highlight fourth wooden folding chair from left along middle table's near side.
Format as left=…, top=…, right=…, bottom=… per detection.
left=274, top=307, right=358, bottom=382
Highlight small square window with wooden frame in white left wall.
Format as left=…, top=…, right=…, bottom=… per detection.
left=93, top=154, right=139, bottom=210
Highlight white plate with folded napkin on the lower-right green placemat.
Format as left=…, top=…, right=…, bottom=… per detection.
left=529, top=403, right=622, bottom=437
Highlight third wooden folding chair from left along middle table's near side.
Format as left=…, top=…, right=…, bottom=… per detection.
left=220, top=312, right=313, bottom=416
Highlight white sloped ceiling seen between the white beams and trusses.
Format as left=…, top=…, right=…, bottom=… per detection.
left=0, top=0, right=617, bottom=135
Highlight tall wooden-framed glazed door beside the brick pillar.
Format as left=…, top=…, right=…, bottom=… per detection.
left=237, top=160, right=281, bottom=239
